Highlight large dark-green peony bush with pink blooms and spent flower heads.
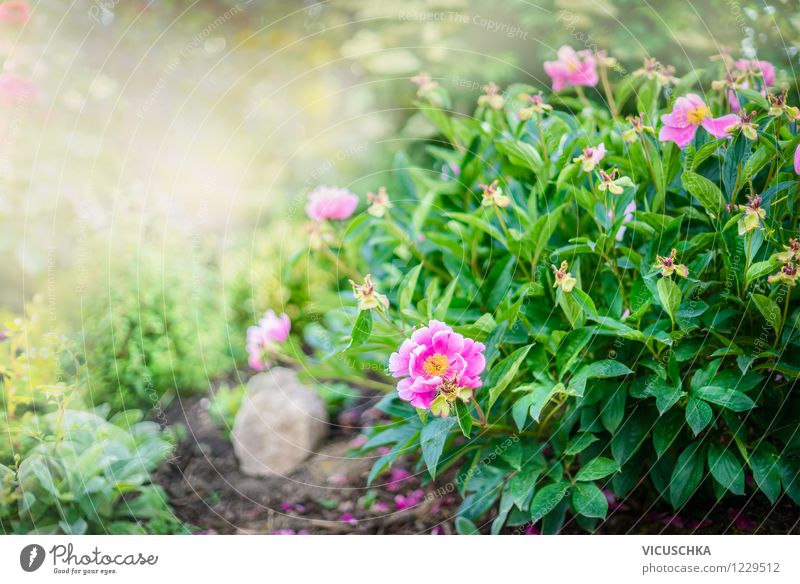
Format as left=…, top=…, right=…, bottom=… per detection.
left=250, top=47, right=800, bottom=533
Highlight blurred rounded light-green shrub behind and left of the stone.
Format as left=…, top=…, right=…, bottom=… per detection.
left=83, top=251, right=233, bottom=411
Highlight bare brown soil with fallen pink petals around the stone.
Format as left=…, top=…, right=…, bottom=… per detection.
left=156, top=398, right=800, bottom=534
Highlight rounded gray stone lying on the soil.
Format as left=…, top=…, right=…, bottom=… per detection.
left=231, top=367, right=328, bottom=476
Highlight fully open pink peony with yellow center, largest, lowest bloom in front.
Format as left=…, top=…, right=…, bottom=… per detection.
left=389, top=320, right=486, bottom=409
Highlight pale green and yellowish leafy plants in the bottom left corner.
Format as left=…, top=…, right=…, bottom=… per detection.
left=0, top=302, right=185, bottom=534
